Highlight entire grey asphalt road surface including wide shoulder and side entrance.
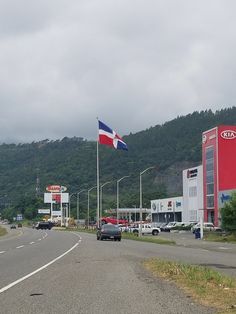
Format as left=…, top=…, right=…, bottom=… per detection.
left=0, top=228, right=236, bottom=314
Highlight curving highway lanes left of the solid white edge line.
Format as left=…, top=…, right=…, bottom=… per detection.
left=0, top=228, right=79, bottom=289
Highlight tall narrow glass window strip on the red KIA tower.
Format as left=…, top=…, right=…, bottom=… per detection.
left=205, top=146, right=214, bottom=208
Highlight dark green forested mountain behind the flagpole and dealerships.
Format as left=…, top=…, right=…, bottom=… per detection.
left=0, top=107, right=236, bottom=220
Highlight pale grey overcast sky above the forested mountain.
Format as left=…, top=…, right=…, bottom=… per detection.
left=0, top=0, right=236, bottom=143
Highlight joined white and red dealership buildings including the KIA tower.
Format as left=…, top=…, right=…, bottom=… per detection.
left=151, top=125, right=236, bottom=226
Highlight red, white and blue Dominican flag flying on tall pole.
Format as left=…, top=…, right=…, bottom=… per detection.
left=98, top=120, right=128, bottom=150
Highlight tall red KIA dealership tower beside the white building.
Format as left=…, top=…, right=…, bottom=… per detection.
left=202, top=125, right=236, bottom=226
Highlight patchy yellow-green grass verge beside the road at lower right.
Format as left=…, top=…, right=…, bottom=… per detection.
left=144, top=259, right=236, bottom=314
